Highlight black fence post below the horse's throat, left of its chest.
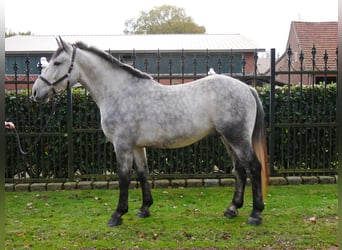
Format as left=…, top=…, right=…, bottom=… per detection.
left=67, top=88, right=74, bottom=181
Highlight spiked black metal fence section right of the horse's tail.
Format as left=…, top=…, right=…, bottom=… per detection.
left=269, top=45, right=338, bottom=175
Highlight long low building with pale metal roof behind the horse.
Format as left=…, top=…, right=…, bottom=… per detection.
left=5, top=34, right=265, bottom=84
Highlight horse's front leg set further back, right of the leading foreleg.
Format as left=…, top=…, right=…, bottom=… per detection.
left=133, top=148, right=153, bottom=218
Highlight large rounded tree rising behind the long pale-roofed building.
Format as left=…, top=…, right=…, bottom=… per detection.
left=124, top=5, right=205, bottom=35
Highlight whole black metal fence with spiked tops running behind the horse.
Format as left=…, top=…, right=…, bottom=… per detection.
left=5, top=47, right=337, bottom=182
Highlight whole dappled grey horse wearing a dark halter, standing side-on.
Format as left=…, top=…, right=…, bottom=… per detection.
left=32, top=38, right=268, bottom=226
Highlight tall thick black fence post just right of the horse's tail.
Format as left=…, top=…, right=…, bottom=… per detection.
left=269, top=49, right=275, bottom=176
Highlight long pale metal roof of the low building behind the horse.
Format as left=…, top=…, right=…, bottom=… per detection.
left=5, top=34, right=265, bottom=54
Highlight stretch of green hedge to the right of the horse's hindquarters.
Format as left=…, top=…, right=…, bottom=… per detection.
left=259, top=84, right=337, bottom=174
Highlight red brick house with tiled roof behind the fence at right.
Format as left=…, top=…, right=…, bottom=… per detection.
left=276, top=21, right=338, bottom=85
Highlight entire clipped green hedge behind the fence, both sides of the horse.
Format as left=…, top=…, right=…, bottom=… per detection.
left=5, top=84, right=337, bottom=178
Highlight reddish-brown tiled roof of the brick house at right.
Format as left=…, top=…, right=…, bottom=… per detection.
left=290, top=22, right=338, bottom=67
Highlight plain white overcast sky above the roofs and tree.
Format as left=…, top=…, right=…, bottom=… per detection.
left=5, top=0, right=338, bottom=54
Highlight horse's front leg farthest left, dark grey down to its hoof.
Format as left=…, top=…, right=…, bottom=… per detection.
left=108, top=150, right=133, bottom=227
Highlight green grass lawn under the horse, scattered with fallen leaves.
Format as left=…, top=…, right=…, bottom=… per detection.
left=5, top=185, right=338, bottom=249
